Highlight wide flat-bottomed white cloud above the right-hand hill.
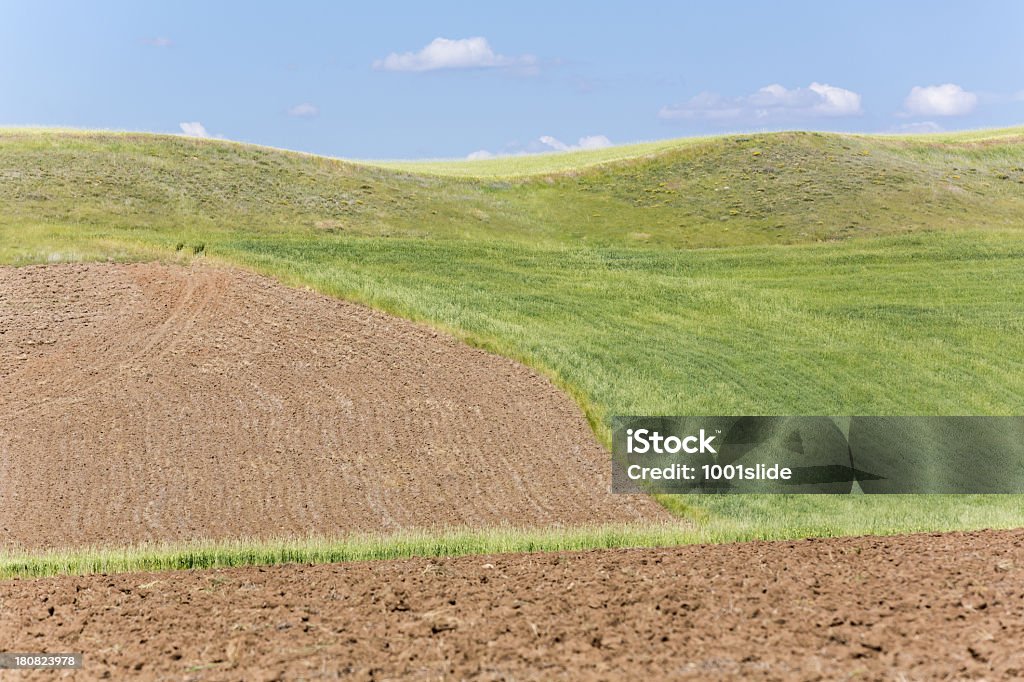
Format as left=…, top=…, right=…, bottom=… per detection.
left=657, top=83, right=863, bottom=122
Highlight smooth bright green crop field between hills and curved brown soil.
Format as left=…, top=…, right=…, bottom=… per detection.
left=9, top=226, right=1024, bottom=430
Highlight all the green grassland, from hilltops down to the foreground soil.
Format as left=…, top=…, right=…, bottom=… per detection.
left=0, top=129, right=1024, bottom=573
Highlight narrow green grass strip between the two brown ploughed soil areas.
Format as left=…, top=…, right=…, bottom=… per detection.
left=0, top=496, right=1020, bottom=580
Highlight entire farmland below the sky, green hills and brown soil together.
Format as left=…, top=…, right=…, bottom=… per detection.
left=0, top=128, right=1024, bottom=679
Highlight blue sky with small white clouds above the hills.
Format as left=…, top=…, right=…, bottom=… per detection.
left=0, top=0, right=1024, bottom=158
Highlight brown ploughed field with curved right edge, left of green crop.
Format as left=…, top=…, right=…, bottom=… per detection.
left=0, top=263, right=668, bottom=549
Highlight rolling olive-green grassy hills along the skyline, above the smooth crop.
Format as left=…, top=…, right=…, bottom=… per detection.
left=0, top=130, right=1024, bottom=248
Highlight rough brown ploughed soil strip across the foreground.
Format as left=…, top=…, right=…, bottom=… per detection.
left=0, top=530, right=1024, bottom=680
